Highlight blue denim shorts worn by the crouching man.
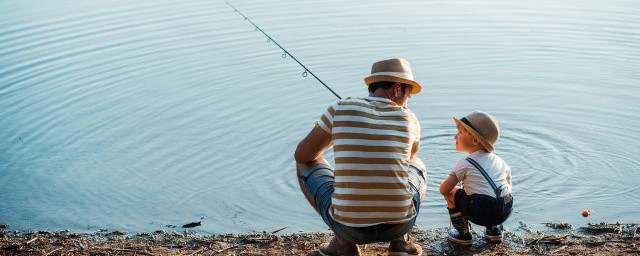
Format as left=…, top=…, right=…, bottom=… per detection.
left=301, top=163, right=427, bottom=244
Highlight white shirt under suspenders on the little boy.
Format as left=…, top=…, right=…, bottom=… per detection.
left=450, top=150, right=511, bottom=197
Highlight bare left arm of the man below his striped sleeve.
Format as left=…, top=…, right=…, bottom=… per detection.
left=294, top=125, right=331, bottom=164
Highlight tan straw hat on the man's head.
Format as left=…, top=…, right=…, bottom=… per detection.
left=364, top=58, right=422, bottom=94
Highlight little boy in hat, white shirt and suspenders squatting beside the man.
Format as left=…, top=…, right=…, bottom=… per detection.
left=440, top=111, right=513, bottom=245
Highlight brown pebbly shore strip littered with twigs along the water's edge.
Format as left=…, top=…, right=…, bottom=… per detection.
left=0, top=223, right=640, bottom=255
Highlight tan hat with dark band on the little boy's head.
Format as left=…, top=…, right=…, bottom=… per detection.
left=453, top=110, right=500, bottom=152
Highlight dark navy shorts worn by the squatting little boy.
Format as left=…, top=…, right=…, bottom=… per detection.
left=453, top=189, right=513, bottom=227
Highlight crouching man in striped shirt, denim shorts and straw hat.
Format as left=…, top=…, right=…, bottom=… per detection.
left=295, top=58, right=427, bottom=255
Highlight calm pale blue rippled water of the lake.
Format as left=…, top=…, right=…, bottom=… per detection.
left=0, top=0, right=640, bottom=234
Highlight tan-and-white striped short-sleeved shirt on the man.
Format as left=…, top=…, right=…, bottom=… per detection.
left=316, top=97, right=420, bottom=227
